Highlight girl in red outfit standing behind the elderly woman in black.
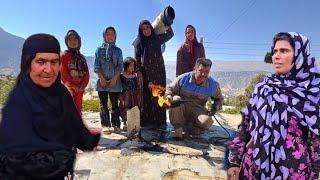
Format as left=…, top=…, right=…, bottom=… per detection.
left=61, top=30, right=89, bottom=115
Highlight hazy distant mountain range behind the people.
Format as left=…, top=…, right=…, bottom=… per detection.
left=0, top=28, right=319, bottom=97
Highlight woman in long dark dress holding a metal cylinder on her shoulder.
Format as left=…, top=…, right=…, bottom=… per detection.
left=133, top=20, right=173, bottom=128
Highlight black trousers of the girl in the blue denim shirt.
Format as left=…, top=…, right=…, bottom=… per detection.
left=98, top=91, right=120, bottom=127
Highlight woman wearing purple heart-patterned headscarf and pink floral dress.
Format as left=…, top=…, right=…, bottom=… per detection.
left=228, top=33, right=320, bottom=179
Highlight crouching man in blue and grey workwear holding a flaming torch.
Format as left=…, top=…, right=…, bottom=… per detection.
left=165, top=58, right=223, bottom=139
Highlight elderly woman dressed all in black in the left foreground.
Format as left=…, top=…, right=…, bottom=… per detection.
left=0, top=34, right=100, bottom=179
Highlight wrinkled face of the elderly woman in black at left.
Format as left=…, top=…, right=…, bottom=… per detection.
left=30, top=53, right=60, bottom=88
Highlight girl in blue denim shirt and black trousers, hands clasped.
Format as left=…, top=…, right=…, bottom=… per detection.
left=94, top=27, right=123, bottom=133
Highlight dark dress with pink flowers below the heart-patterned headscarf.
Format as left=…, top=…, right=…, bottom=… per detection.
left=229, top=117, right=320, bottom=180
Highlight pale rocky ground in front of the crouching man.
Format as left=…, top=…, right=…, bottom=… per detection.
left=75, top=113, right=240, bottom=180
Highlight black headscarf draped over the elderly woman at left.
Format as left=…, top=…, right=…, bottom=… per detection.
left=0, top=34, right=99, bottom=151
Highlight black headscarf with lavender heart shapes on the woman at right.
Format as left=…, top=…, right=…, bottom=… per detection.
left=242, top=32, right=320, bottom=177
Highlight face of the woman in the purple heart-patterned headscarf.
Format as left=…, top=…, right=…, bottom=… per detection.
left=272, top=40, right=294, bottom=74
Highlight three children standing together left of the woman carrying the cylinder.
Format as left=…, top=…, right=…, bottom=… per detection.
left=61, top=27, right=140, bottom=132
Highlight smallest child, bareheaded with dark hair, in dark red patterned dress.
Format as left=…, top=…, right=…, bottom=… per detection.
left=120, top=57, right=140, bottom=131
